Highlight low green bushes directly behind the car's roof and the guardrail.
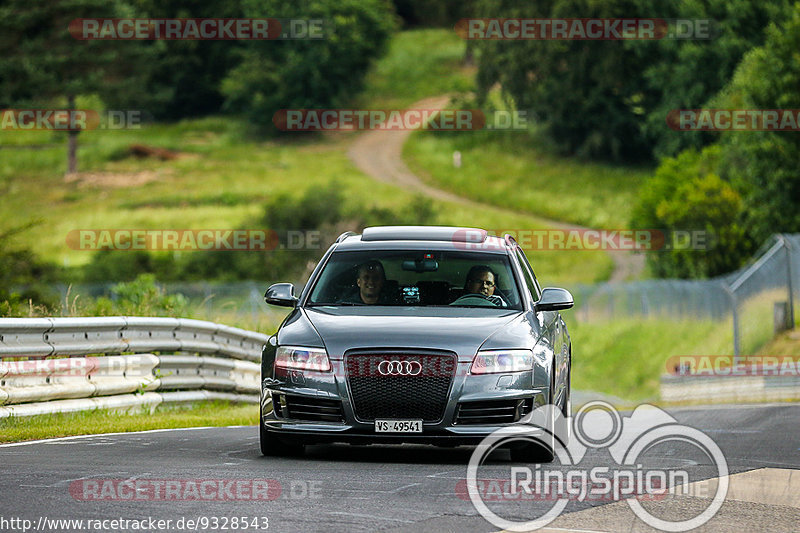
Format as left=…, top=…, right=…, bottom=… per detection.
left=80, top=182, right=436, bottom=282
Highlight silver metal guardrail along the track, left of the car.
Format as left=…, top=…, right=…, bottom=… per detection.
left=0, top=317, right=267, bottom=418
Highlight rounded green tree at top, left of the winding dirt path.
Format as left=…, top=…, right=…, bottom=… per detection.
left=222, top=0, right=394, bottom=129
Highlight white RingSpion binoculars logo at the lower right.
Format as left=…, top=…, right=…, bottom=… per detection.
left=466, top=401, right=729, bottom=532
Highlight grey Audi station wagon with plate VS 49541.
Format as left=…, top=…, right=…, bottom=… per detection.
left=259, top=226, right=573, bottom=461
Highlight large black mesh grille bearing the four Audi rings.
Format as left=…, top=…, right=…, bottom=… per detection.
left=345, top=354, right=456, bottom=422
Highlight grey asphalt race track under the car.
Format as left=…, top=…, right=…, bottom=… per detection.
left=0, top=404, right=800, bottom=532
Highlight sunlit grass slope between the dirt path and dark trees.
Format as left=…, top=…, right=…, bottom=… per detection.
left=404, top=131, right=652, bottom=229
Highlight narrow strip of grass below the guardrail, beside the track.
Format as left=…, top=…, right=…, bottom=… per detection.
left=0, top=402, right=258, bottom=442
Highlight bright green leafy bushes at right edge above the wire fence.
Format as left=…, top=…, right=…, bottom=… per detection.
left=633, top=4, right=800, bottom=277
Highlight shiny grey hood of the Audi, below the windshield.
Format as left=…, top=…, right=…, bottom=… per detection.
left=304, top=307, right=531, bottom=361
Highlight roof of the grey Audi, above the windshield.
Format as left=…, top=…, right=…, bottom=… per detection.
left=336, top=226, right=513, bottom=253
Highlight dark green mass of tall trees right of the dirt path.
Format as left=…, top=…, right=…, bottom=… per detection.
left=478, top=0, right=789, bottom=161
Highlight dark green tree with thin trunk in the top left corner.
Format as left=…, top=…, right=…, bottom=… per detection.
left=0, top=0, right=142, bottom=173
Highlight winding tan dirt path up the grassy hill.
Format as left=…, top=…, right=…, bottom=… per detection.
left=347, top=96, right=644, bottom=282
